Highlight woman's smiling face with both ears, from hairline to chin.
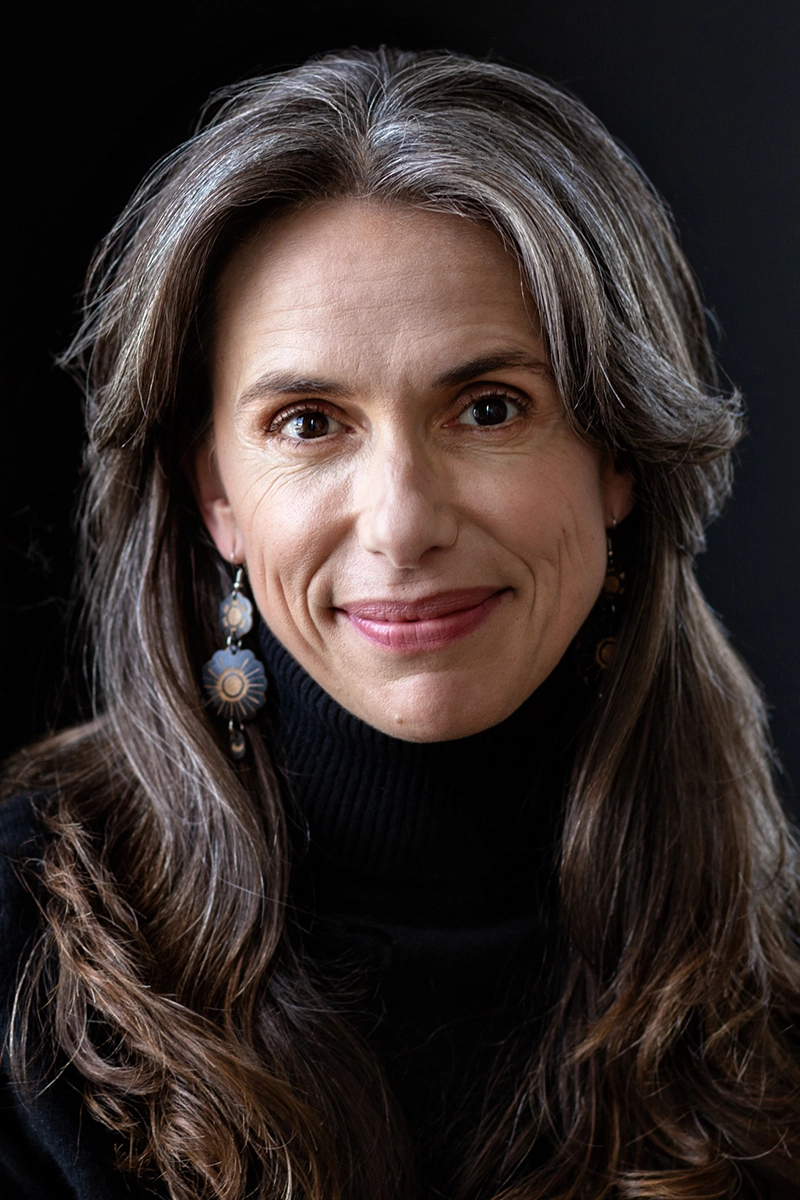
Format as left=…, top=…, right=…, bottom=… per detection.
left=194, top=200, right=632, bottom=742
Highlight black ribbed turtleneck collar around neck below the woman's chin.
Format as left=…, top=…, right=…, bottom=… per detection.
left=259, top=624, right=587, bottom=922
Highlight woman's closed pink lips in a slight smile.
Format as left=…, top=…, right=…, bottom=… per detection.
left=338, top=588, right=509, bottom=652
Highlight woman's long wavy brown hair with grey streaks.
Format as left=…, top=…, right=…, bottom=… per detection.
left=11, top=50, right=800, bottom=1200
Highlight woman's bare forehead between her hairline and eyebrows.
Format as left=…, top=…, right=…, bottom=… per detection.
left=209, top=200, right=539, bottom=384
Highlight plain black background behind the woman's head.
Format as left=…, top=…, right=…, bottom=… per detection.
left=0, top=0, right=800, bottom=804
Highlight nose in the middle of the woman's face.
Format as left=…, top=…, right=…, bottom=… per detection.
left=357, top=439, right=458, bottom=569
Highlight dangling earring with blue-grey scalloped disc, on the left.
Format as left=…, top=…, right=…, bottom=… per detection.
left=203, top=566, right=266, bottom=758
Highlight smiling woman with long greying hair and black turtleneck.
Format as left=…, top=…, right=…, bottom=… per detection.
left=2, top=50, right=800, bottom=1200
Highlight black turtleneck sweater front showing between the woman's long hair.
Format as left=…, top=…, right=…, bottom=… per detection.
left=259, top=626, right=587, bottom=1194
